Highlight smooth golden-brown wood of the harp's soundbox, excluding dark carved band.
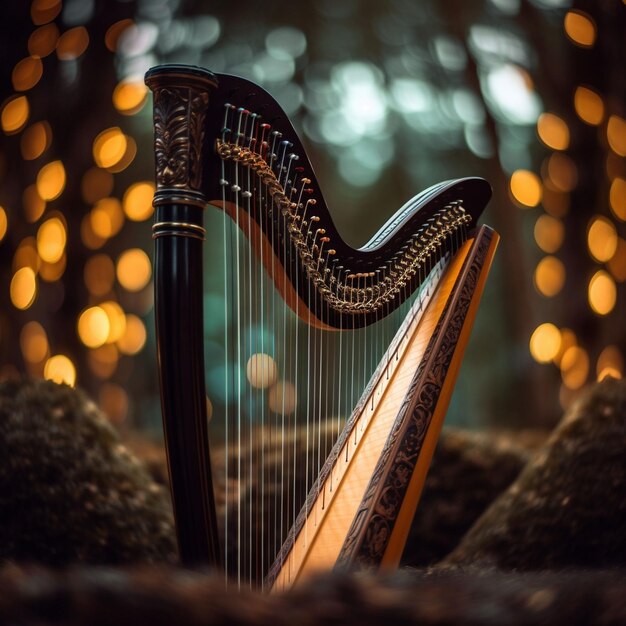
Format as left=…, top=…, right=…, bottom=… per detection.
left=270, top=227, right=497, bottom=591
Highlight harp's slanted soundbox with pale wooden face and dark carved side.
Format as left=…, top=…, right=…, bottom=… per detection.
left=269, top=228, right=497, bottom=590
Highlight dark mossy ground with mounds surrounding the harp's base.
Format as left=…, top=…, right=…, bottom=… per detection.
left=0, top=372, right=626, bottom=625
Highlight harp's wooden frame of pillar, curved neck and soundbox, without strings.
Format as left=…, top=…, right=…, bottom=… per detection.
left=146, top=66, right=497, bottom=589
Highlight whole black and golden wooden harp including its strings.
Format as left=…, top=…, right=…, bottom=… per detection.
left=146, top=65, right=498, bottom=589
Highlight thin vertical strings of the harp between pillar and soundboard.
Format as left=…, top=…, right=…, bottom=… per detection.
left=211, top=104, right=464, bottom=586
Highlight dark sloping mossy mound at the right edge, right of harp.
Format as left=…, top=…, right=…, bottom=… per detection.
left=443, top=379, right=626, bottom=570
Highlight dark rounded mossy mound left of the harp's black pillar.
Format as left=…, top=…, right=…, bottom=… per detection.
left=0, top=381, right=176, bottom=566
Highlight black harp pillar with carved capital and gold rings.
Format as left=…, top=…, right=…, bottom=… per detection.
left=146, top=65, right=220, bottom=566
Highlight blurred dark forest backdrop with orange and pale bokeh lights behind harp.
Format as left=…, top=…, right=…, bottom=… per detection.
left=0, top=0, right=626, bottom=435
